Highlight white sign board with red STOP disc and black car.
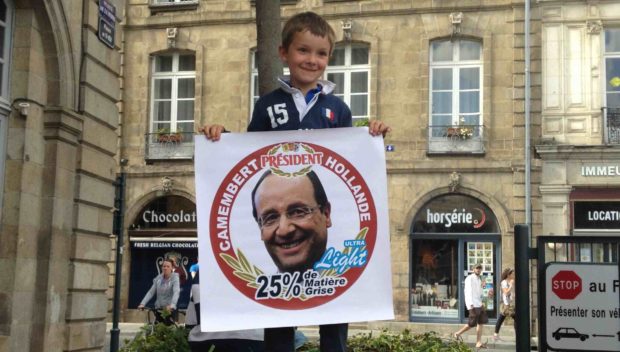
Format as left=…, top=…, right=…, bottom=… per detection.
left=545, top=263, right=620, bottom=351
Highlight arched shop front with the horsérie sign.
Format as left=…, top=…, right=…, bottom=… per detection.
left=409, top=194, right=501, bottom=323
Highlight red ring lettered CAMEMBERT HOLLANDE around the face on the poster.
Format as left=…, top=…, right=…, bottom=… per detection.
left=209, top=142, right=377, bottom=310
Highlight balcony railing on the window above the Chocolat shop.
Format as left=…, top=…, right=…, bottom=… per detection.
left=145, top=132, right=194, bottom=160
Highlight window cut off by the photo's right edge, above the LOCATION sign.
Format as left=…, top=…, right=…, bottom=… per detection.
left=603, top=29, right=620, bottom=144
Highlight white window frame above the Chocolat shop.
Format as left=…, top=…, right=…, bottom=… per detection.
left=149, top=52, right=196, bottom=133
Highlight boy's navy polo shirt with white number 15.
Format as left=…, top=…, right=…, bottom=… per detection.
left=248, top=80, right=352, bottom=132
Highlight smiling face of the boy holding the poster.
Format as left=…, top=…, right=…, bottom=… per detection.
left=280, top=31, right=331, bottom=94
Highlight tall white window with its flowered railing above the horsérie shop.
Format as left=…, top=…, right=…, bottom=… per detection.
left=428, top=39, right=484, bottom=153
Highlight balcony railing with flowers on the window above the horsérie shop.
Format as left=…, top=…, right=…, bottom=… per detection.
left=428, top=125, right=484, bottom=154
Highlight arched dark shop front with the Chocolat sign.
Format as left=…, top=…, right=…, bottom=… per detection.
left=127, top=195, right=198, bottom=310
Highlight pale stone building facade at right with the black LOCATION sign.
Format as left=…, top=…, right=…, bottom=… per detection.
left=536, top=0, right=620, bottom=262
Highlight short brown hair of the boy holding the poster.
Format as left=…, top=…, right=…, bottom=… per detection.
left=282, top=11, right=336, bottom=56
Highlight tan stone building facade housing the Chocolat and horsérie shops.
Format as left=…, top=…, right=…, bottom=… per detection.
left=120, top=0, right=541, bottom=329
